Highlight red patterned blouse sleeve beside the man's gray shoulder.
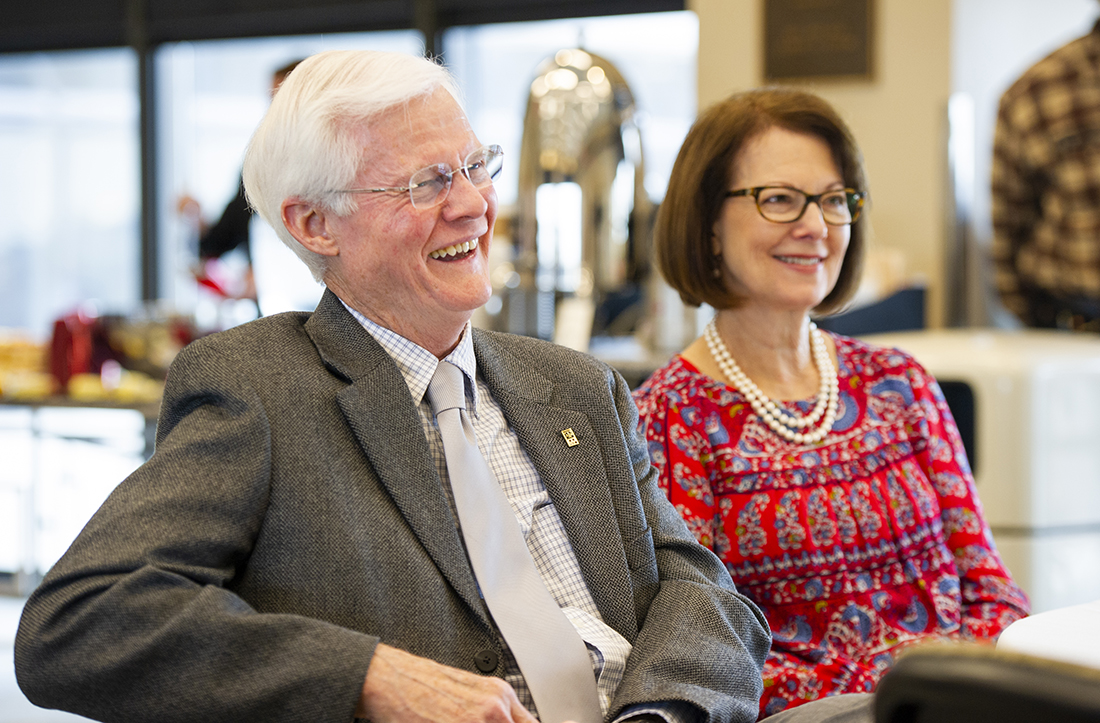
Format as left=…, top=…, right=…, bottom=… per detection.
left=635, top=388, right=719, bottom=552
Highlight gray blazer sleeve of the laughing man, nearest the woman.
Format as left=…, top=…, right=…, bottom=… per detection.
left=612, top=372, right=771, bottom=723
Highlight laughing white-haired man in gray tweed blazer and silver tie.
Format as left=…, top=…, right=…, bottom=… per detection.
left=15, top=52, right=792, bottom=723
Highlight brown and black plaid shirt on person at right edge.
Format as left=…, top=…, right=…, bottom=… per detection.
left=992, top=22, right=1100, bottom=318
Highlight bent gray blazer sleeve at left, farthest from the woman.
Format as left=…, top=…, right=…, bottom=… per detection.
left=14, top=343, right=377, bottom=723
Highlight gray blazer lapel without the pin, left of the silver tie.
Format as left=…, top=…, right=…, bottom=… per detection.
left=306, top=291, right=492, bottom=628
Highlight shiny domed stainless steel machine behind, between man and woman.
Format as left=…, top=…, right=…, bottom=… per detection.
left=496, top=48, right=653, bottom=350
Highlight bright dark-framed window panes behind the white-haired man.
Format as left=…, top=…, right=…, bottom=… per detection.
left=0, top=12, right=697, bottom=340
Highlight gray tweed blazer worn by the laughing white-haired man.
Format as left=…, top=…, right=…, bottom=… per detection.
left=15, top=292, right=770, bottom=723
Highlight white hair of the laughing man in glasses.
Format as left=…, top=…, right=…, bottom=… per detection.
left=243, top=51, right=461, bottom=281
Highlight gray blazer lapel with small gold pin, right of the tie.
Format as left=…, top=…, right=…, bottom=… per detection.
left=474, top=333, right=637, bottom=639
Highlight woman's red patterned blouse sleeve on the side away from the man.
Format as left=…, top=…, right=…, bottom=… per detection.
left=910, top=362, right=1030, bottom=639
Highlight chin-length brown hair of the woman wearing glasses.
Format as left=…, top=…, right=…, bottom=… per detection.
left=656, top=88, right=867, bottom=314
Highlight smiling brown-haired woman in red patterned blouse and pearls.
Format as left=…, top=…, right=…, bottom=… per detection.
left=635, top=89, right=1027, bottom=716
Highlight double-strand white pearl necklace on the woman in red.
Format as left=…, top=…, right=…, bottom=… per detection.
left=704, top=317, right=839, bottom=445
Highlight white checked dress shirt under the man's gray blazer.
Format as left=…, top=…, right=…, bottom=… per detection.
left=344, top=304, right=697, bottom=723
